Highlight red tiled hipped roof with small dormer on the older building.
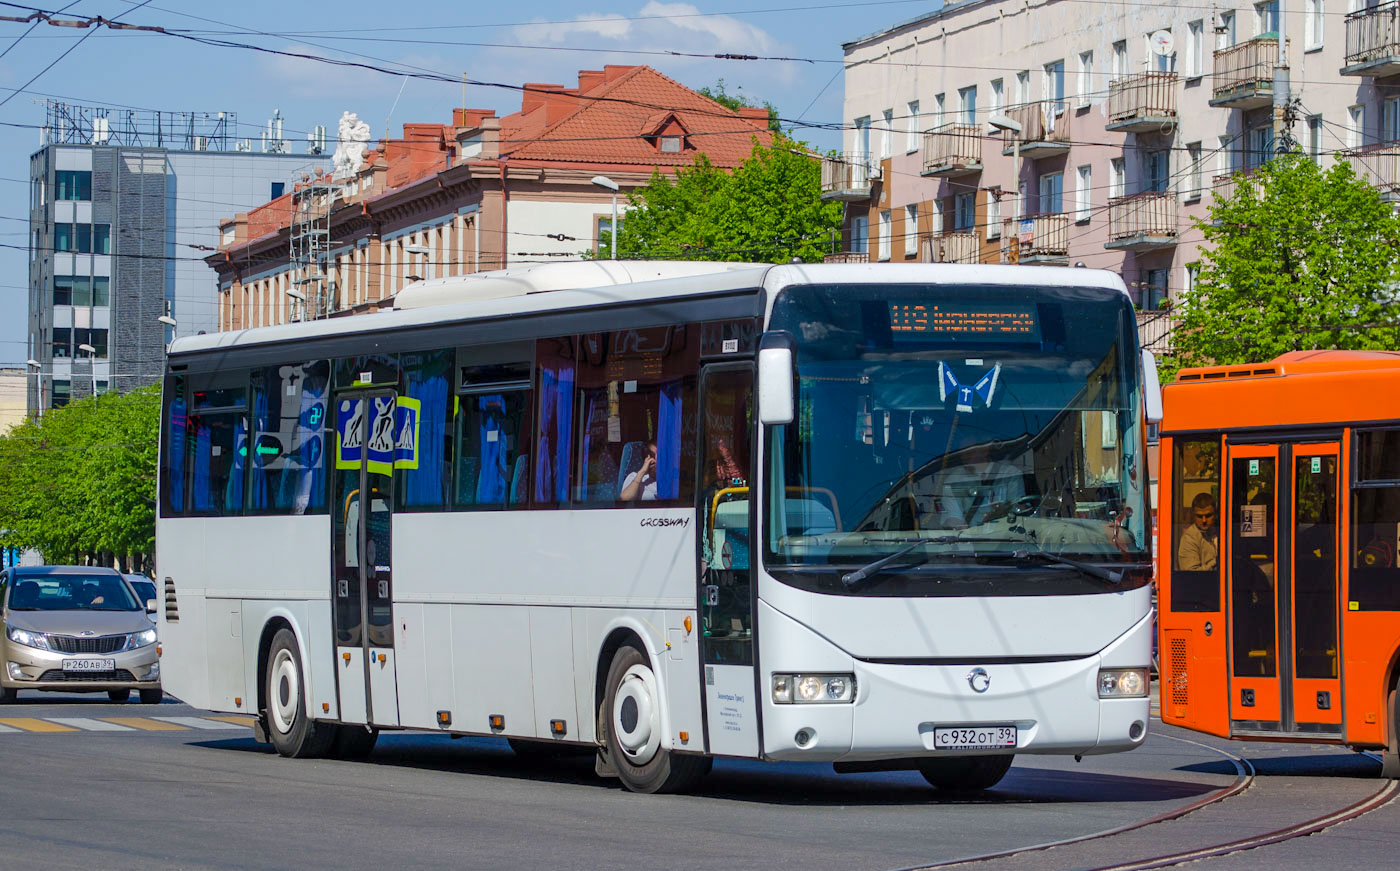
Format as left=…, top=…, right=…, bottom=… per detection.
left=501, top=66, right=771, bottom=167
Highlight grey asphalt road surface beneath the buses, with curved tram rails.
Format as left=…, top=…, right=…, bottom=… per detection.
left=0, top=696, right=1400, bottom=871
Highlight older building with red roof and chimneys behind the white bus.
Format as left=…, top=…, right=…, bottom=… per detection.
left=214, top=66, right=771, bottom=329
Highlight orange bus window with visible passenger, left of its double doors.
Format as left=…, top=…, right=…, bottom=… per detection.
left=1172, top=438, right=1221, bottom=612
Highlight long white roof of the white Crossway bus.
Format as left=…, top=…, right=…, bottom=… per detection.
left=169, top=260, right=1127, bottom=357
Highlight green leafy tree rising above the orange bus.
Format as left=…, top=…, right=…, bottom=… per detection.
left=1165, top=153, right=1400, bottom=377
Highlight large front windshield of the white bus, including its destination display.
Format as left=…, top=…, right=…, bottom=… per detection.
left=764, top=284, right=1149, bottom=595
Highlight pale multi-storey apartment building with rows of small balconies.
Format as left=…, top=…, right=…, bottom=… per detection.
left=823, top=0, right=1383, bottom=339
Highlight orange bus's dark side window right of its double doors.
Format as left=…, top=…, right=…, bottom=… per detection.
left=1347, top=430, right=1400, bottom=611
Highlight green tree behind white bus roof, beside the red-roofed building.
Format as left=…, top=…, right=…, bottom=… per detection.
left=598, top=136, right=841, bottom=263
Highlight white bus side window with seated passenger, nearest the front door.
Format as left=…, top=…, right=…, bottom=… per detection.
left=574, top=326, right=699, bottom=506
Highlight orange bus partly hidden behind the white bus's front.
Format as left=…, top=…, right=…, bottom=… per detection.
left=1158, top=351, right=1400, bottom=777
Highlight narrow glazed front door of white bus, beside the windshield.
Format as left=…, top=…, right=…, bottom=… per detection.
left=697, top=363, right=759, bottom=756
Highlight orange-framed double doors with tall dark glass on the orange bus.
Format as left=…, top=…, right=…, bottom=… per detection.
left=1225, top=443, right=1341, bottom=735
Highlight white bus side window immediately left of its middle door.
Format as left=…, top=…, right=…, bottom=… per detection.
left=248, top=360, right=330, bottom=514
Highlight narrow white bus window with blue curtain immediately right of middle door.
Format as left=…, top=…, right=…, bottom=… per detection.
left=393, top=350, right=455, bottom=511
